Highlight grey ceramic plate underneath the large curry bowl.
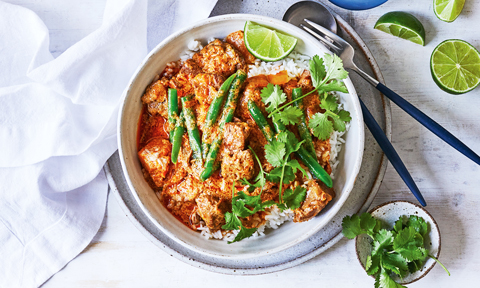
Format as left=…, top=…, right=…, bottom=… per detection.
left=105, top=12, right=391, bottom=275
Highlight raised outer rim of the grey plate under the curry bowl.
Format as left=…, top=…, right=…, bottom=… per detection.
left=104, top=7, right=392, bottom=275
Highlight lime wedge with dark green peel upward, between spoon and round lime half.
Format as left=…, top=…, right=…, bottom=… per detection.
left=374, top=11, right=425, bottom=46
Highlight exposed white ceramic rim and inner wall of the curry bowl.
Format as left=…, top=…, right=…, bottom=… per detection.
left=118, top=14, right=364, bottom=260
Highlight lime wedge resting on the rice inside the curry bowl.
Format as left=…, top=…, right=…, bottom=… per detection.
left=243, top=21, right=297, bottom=62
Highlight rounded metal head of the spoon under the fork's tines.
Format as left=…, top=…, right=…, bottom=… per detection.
left=283, top=1, right=337, bottom=34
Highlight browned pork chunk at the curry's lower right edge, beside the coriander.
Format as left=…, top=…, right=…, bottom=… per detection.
left=293, top=180, right=335, bottom=222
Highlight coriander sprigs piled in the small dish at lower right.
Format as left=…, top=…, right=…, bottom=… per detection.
left=342, top=213, right=450, bottom=288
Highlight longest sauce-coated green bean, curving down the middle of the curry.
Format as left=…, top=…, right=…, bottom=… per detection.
left=202, top=74, right=237, bottom=160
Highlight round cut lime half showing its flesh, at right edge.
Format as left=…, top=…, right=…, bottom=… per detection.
left=430, top=39, right=480, bottom=94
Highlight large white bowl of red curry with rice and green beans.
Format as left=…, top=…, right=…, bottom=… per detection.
left=118, top=14, right=364, bottom=261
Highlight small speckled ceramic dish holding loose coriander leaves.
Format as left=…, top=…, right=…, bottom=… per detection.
left=355, top=201, right=441, bottom=285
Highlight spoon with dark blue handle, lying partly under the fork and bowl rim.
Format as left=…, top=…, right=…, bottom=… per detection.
left=283, top=1, right=427, bottom=206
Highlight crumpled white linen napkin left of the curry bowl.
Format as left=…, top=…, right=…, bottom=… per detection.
left=0, top=0, right=216, bottom=288
